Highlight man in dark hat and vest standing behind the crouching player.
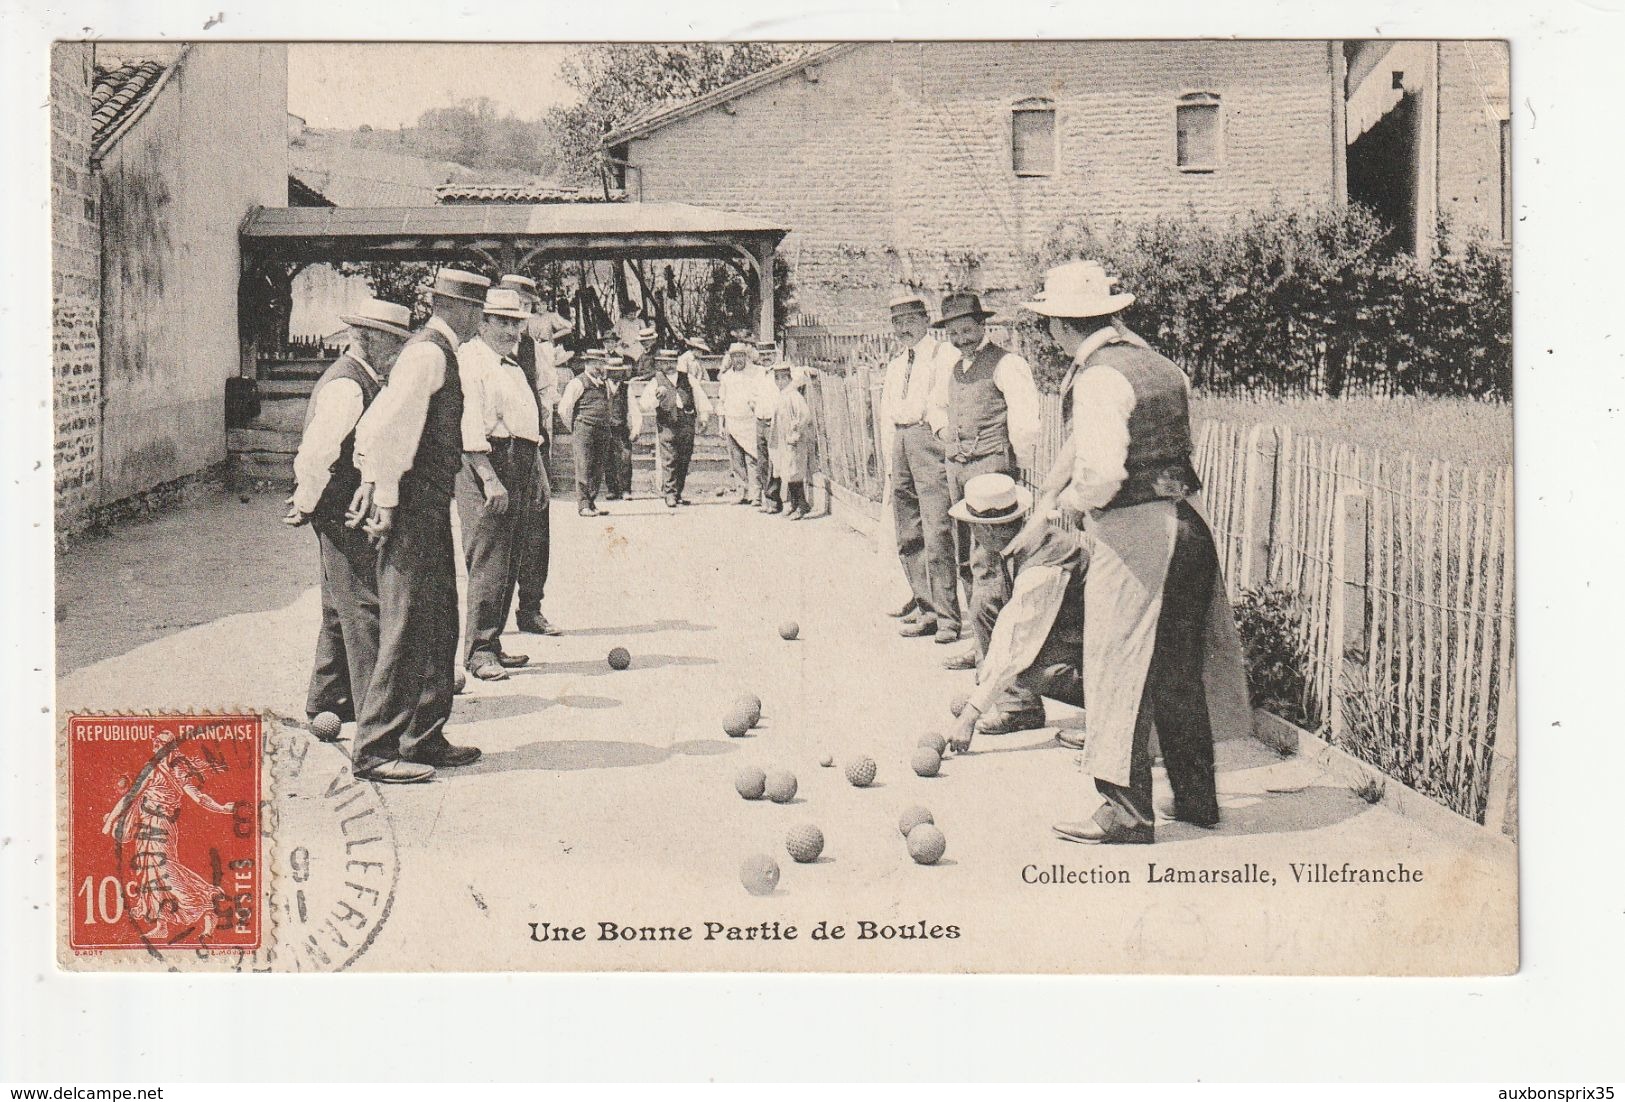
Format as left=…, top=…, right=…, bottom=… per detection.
left=936, top=291, right=1038, bottom=669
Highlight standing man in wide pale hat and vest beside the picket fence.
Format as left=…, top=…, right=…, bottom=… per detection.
left=1011, top=260, right=1251, bottom=844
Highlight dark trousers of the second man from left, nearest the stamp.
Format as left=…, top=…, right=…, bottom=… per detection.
left=351, top=502, right=458, bottom=772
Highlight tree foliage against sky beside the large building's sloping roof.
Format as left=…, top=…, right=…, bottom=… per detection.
left=548, top=42, right=816, bottom=182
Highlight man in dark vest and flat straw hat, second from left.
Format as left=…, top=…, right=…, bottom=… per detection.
left=348, top=268, right=491, bottom=783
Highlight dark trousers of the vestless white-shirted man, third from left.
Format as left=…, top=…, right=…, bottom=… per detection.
left=457, top=437, right=540, bottom=663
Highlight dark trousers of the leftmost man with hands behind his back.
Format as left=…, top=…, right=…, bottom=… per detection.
left=306, top=518, right=379, bottom=722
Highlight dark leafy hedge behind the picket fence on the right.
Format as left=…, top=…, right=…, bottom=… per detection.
left=1021, top=205, right=1511, bottom=400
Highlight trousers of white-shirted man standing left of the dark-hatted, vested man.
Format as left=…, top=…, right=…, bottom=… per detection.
left=891, top=423, right=960, bottom=629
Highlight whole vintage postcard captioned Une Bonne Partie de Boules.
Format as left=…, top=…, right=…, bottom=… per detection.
left=50, top=39, right=1519, bottom=975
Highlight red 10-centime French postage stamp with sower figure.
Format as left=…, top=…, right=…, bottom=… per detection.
left=65, top=715, right=265, bottom=952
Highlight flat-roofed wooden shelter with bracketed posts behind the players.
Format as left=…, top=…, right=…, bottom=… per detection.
left=239, top=203, right=790, bottom=367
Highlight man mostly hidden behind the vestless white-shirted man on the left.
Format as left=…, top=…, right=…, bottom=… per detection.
left=501, top=275, right=570, bottom=636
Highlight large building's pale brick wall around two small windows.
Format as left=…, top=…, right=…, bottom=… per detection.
left=629, top=42, right=1336, bottom=322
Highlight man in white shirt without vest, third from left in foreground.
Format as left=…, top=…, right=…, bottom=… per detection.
left=457, top=288, right=543, bottom=681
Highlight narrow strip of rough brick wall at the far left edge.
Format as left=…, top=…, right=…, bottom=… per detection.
left=50, top=42, right=101, bottom=531
